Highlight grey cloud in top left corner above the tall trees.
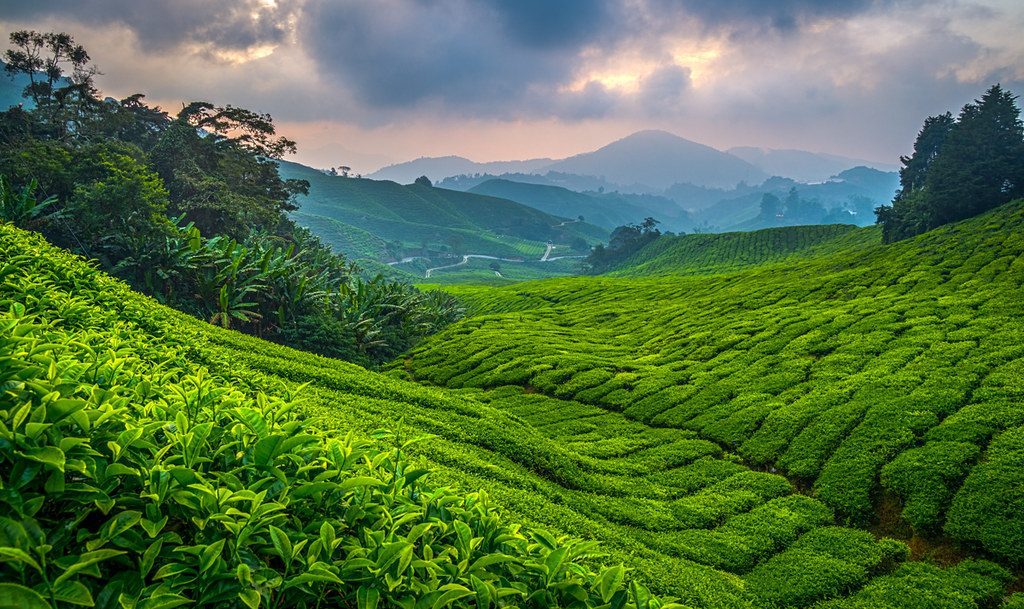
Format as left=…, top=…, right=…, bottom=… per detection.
left=3, top=0, right=294, bottom=51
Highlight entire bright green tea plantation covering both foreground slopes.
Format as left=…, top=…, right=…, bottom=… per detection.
left=0, top=204, right=1024, bottom=609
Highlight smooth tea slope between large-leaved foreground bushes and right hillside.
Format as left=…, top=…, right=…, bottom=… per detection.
left=0, top=220, right=1005, bottom=608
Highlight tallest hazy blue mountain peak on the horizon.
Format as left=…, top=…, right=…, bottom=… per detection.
left=545, top=131, right=768, bottom=189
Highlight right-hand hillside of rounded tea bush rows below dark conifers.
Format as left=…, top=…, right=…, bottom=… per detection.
left=403, top=201, right=1024, bottom=569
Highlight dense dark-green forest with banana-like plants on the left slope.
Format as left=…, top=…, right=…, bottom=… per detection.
left=0, top=31, right=460, bottom=364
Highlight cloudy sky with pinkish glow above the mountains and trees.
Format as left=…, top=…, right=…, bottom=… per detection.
left=0, top=0, right=1024, bottom=173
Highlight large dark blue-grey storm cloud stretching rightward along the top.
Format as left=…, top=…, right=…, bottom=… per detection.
left=299, top=0, right=905, bottom=118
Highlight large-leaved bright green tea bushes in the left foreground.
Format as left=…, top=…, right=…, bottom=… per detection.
left=0, top=228, right=679, bottom=609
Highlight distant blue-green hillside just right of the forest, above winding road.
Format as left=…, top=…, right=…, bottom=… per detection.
left=281, top=162, right=607, bottom=272
